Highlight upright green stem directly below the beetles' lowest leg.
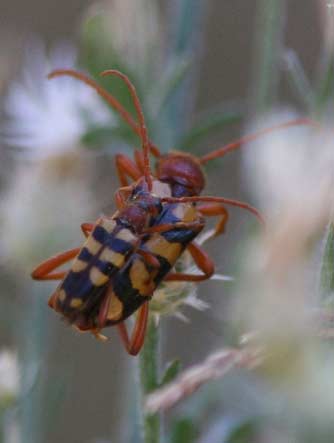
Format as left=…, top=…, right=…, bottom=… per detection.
left=139, top=319, right=160, bottom=443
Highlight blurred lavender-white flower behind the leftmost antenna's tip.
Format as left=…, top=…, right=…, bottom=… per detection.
left=1, top=39, right=112, bottom=158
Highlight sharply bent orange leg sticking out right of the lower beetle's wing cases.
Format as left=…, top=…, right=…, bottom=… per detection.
left=165, top=243, right=215, bottom=281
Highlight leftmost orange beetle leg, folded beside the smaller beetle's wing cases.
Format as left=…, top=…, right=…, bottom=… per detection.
left=31, top=248, right=81, bottom=280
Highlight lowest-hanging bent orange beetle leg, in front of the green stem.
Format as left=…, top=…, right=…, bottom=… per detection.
left=117, top=301, right=148, bottom=355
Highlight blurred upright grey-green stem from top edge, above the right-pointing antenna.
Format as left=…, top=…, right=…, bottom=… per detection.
left=253, top=0, right=285, bottom=114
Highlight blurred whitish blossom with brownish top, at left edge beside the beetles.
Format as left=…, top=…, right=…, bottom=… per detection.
left=0, top=159, right=97, bottom=273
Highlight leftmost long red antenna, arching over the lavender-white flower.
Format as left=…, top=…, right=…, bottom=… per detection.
left=48, top=69, right=160, bottom=157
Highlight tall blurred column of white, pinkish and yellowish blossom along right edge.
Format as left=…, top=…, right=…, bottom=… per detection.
left=234, top=111, right=334, bottom=412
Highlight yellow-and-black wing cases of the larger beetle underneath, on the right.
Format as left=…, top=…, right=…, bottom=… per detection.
left=97, top=203, right=205, bottom=328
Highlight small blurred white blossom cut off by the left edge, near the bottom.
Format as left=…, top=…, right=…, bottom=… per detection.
left=0, top=349, right=20, bottom=407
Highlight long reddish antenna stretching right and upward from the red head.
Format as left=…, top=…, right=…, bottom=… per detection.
left=199, top=118, right=319, bottom=164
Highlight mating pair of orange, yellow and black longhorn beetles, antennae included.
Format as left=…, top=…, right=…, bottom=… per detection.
left=32, top=69, right=310, bottom=355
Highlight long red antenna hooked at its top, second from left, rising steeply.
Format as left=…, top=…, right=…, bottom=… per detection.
left=101, top=69, right=152, bottom=191
